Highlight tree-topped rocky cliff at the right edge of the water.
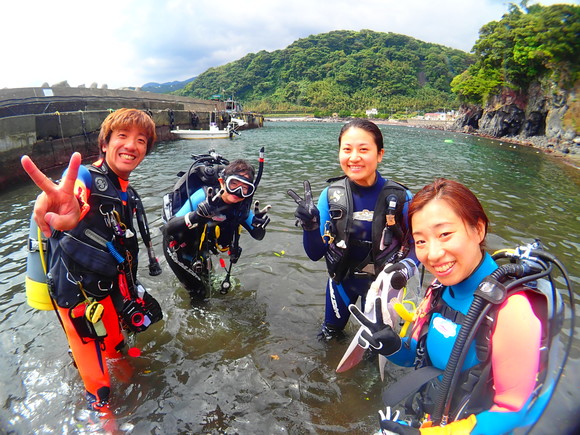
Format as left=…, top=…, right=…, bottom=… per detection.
left=451, top=0, right=580, bottom=146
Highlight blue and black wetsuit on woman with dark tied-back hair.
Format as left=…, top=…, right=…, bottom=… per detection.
left=303, top=172, right=412, bottom=333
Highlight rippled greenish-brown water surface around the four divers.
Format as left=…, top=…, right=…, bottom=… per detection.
left=0, top=122, right=580, bottom=434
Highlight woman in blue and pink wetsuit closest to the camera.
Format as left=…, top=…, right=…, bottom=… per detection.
left=353, top=179, right=542, bottom=435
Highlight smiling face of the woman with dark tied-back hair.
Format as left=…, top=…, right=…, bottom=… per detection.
left=338, top=127, right=385, bottom=186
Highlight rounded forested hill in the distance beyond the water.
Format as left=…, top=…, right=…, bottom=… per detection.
left=177, top=30, right=474, bottom=114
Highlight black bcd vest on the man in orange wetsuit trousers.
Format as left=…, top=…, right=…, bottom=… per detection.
left=47, top=165, right=142, bottom=308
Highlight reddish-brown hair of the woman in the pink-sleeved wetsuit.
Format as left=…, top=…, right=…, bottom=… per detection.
left=409, top=178, right=489, bottom=247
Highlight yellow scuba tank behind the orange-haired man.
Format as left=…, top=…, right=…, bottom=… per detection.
left=25, top=216, right=54, bottom=311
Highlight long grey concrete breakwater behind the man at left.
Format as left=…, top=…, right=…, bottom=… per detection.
left=0, top=87, right=263, bottom=190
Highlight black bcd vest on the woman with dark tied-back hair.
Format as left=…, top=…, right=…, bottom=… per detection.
left=325, top=176, right=407, bottom=283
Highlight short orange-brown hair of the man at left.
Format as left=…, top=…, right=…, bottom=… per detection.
left=99, top=109, right=157, bottom=154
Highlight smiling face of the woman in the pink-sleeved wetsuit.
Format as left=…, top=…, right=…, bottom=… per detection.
left=412, top=199, right=485, bottom=286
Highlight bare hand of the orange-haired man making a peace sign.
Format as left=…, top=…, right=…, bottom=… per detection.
left=20, top=153, right=81, bottom=237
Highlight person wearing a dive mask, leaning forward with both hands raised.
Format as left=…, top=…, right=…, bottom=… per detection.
left=164, top=159, right=270, bottom=299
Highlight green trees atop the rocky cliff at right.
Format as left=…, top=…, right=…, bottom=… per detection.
left=451, top=0, right=580, bottom=105
